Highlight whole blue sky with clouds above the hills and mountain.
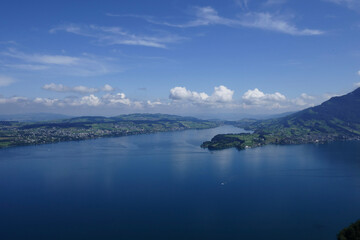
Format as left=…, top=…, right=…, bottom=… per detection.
left=0, top=0, right=360, bottom=115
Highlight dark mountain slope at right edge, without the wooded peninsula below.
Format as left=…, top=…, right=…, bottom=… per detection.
left=255, top=88, right=360, bottom=137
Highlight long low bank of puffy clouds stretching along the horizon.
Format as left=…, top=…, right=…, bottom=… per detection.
left=0, top=83, right=325, bottom=114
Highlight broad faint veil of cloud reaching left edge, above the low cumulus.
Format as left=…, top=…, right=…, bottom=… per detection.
left=0, top=48, right=119, bottom=76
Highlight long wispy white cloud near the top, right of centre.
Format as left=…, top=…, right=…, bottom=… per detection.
left=151, top=6, right=324, bottom=36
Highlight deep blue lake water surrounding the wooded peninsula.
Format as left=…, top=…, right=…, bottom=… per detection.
left=0, top=126, right=360, bottom=240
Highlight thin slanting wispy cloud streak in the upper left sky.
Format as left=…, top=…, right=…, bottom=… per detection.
left=50, top=24, right=184, bottom=48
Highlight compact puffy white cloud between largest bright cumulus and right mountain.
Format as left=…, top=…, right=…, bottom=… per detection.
left=242, top=88, right=287, bottom=108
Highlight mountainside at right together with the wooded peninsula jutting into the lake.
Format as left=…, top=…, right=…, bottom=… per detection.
left=202, top=88, right=360, bottom=149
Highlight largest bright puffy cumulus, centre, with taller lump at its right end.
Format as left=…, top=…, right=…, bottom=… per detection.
left=169, top=85, right=234, bottom=106
